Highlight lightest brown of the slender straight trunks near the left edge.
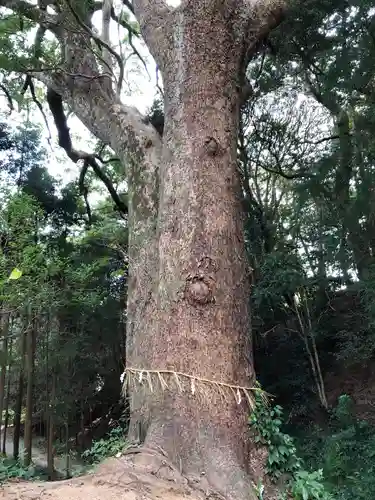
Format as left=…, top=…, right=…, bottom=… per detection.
left=24, top=317, right=36, bottom=467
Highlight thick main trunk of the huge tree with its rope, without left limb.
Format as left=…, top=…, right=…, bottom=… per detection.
left=127, top=0, right=281, bottom=498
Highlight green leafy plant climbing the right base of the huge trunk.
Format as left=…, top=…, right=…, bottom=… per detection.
left=249, top=397, right=332, bottom=500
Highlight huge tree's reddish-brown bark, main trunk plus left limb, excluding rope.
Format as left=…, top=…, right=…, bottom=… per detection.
left=0, top=0, right=285, bottom=498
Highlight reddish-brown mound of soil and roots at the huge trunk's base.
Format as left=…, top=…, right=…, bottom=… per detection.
left=0, top=448, right=262, bottom=500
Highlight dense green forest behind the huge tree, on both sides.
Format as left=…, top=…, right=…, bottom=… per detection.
left=0, top=0, right=375, bottom=500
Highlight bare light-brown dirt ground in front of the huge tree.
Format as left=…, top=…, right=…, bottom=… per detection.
left=0, top=459, right=218, bottom=500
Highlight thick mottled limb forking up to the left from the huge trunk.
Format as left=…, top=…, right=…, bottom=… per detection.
left=8, top=0, right=162, bottom=227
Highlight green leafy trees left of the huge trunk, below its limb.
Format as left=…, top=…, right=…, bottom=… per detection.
left=0, top=116, right=127, bottom=476
